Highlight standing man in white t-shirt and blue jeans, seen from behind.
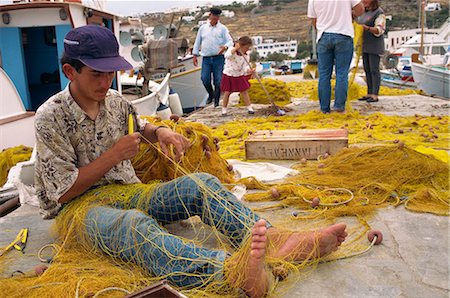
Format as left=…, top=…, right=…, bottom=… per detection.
left=308, top=0, right=364, bottom=113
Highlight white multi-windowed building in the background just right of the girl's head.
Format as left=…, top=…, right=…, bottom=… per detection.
left=252, top=36, right=298, bottom=58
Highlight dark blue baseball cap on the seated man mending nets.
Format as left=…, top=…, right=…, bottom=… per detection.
left=64, top=25, right=133, bottom=72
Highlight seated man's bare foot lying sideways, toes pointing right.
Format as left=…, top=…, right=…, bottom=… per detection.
left=268, top=223, right=347, bottom=261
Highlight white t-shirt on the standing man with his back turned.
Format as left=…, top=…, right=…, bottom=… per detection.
left=308, top=0, right=361, bottom=41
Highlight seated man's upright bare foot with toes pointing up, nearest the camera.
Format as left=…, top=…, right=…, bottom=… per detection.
left=229, top=219, right=269, bottom=298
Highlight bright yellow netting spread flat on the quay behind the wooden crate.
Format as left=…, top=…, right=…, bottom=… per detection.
left=213, top=111, right=450, bottom=159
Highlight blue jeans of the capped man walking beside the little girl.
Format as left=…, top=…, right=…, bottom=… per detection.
left=202, top=55, right=225, bottom=106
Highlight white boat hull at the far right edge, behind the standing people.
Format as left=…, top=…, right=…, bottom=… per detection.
left=412, top=63, right=450, bottom=99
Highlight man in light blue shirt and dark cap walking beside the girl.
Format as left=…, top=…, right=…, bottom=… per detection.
left=192, top=7, right=233, bottom=107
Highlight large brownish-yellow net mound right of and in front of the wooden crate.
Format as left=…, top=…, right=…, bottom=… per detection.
left=246, top=144, right=450, bottom=218
